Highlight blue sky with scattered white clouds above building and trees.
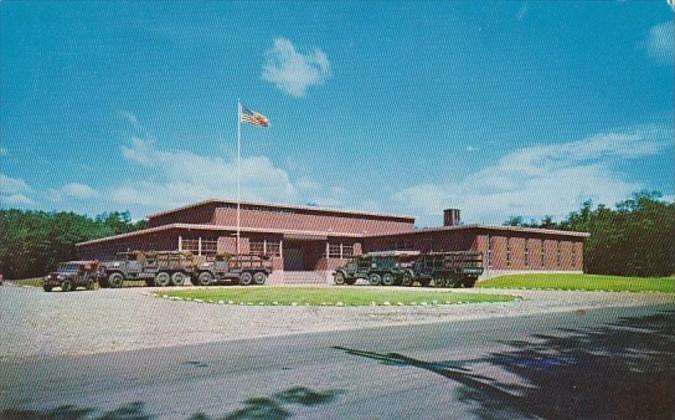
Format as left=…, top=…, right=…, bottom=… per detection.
left=0, top=0, right=675, bottom=226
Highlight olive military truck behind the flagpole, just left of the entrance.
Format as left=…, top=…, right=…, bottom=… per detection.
left=192, top=255, right=272, bottom=286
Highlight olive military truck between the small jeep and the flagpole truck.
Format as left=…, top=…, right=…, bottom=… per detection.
left=98, top=251, right=195, bottom=288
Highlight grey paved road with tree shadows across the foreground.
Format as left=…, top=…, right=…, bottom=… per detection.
left=0, top=305, right=675, bottom=419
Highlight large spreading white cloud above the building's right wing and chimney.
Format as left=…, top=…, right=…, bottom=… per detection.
left=395, top=127, right=674, bottom=223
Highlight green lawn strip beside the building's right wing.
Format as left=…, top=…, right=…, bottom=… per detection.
left=476, top=274, right=675, bottom=293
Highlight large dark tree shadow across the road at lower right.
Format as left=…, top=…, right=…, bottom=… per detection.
left=334, top=311, right=675, bottom=419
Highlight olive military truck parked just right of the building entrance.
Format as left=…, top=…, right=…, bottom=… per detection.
left=333, top=251, right=412, bottom=286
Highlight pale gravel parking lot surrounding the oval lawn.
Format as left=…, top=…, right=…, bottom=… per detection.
left=0, top=284, right=673, bottom=360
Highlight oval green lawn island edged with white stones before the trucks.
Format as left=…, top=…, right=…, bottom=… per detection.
left=158, top=286, right=518, bottom=306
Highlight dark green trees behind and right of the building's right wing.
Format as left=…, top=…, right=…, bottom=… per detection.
left=504, top=191, right=675, bottom=277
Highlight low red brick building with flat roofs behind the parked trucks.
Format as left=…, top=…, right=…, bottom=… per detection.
left=78, top=200, right=588, bottom=283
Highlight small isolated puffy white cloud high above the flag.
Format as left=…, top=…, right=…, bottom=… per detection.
left=262, top=38, right=331, bottom=97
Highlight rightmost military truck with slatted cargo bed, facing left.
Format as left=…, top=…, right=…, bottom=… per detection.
left=412, top=251, right=483, bottom=287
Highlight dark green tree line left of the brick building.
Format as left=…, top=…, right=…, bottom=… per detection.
left=0, top=209, right=147, bottom=279
